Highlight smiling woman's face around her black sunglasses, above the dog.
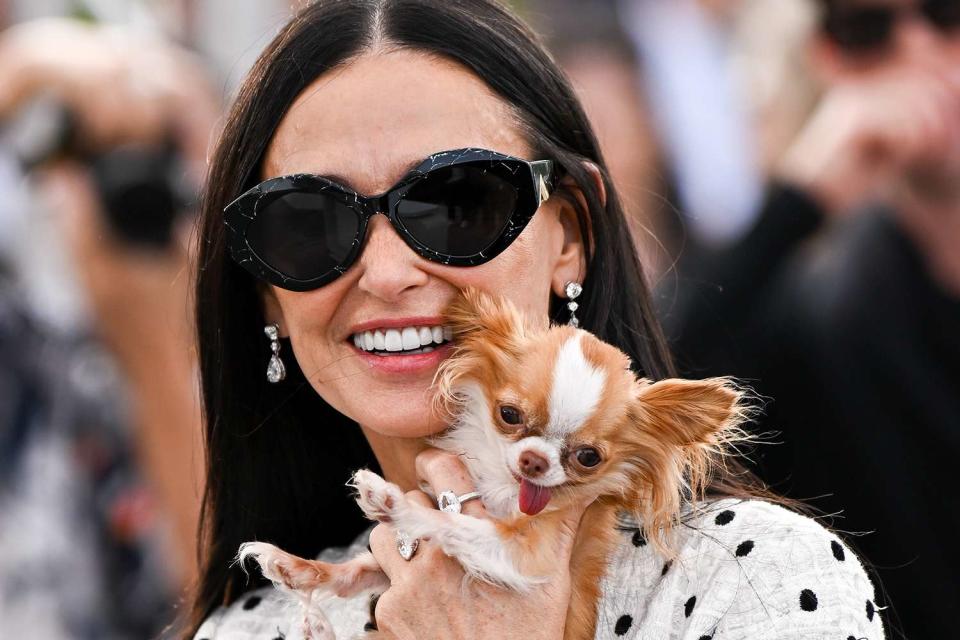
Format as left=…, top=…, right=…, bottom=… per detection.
left=263, top=50, right=583, bottom=437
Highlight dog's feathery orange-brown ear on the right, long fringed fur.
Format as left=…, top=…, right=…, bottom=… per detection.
left=624, top=378, right=752, bottom=553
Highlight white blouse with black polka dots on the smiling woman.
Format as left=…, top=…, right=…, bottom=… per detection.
left=195, top=499, right=885, bottom=640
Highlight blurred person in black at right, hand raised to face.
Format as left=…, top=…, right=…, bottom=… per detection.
left=660, top=0, right=960, bottom=638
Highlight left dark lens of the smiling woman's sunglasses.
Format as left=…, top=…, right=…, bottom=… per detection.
left=247, top=191, right=360, bottom=280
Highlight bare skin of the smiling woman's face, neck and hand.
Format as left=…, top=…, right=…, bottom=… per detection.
left=262, top=48, right=598, bottom=639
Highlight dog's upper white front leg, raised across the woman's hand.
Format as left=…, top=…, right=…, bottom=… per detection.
left=352, top=471, right=542, bottom=591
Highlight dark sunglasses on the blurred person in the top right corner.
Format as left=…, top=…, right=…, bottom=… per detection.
left=823, top=0, right=960, bottom=55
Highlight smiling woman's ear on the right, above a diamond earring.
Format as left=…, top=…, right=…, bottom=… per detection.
left=551, top=161, right=607, bottom=298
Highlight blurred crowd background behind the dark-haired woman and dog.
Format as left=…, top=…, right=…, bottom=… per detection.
left=0, top=0, right=960, bottom=640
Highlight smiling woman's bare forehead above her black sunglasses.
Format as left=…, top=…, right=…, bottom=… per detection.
left=262, top=49, right=529, bottom=195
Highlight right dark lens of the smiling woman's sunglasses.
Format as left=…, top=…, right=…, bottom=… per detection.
left=397, top=165, right=524, bottom=257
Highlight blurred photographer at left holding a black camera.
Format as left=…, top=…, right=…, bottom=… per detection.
left=0, top=19, right=217, bottom=640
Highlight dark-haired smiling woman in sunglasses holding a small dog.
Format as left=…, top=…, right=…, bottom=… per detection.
left=187, top=0, right=883, bottom=638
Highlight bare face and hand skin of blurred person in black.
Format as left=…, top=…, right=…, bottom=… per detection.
left=778, top=0, right=960, bottom=295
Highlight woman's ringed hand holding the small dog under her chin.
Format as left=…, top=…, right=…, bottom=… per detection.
left=370, top=449, right=586, bottom=640
